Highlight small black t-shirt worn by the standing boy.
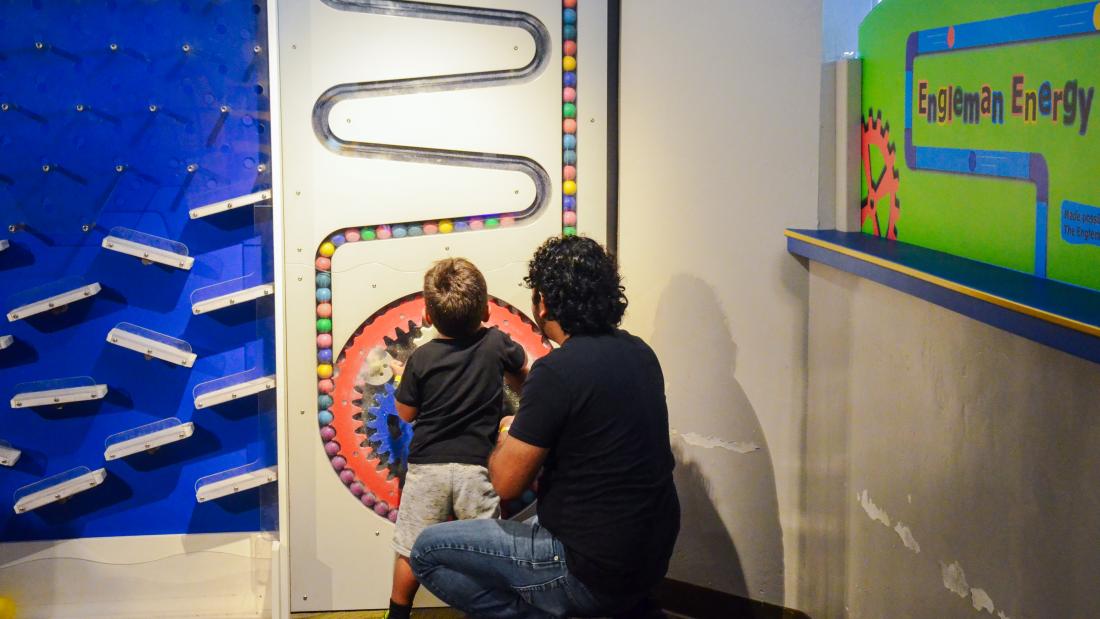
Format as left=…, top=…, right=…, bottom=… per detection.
left=396, top=327, right=527, bottom=466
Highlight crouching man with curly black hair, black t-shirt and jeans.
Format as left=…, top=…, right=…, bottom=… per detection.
left=411, top=236, right=680, bottom=618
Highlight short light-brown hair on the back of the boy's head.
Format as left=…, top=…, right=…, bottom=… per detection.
left=424, top=258, right=488, bottom=338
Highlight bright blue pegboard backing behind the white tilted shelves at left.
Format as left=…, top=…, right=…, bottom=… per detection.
left=0, top=0, right=275, bottom=541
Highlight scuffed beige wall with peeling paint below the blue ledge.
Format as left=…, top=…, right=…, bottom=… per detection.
left=799, top=264, right=1100, bottom=619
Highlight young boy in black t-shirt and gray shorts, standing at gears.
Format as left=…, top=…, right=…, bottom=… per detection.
left=387, top=258, right=527, bottom=619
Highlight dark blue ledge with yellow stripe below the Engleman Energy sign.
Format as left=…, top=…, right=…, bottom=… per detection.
left=787, top=230, right=1100, bottom=363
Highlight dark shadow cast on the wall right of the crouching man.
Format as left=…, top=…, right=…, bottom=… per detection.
left=651, top=275, right=784, bottom=604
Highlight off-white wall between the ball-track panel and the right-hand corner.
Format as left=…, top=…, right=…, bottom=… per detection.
left=624, top=0, right=822, bottom=604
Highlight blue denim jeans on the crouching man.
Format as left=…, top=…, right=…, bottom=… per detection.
left=409, top=520, right=641, bottom=618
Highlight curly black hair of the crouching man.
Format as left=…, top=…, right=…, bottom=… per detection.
left=524, top=236, right=627, bottom=335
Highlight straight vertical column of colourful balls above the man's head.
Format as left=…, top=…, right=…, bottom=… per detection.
left=561, top=0, right=576, bottom=236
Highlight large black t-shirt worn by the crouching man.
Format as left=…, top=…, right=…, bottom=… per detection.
left=509, top=331, right=680, bottom=594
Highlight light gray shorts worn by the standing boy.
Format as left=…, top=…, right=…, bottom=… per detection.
left=394, top=464, right=501, bottom=556
